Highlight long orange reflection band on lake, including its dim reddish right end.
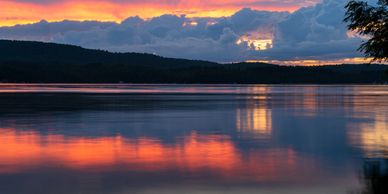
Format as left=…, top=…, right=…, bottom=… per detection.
left=0, top=129, right=303, bottom=181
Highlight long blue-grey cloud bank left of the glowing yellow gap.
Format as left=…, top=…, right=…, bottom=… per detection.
left=0, top=9, right=288, bottom=62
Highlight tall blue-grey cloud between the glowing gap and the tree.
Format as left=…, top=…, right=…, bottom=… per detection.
left=257, top=0, right=368, bottom=60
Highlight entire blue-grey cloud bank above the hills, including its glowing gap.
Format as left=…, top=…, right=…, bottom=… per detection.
left=0, top=0, right=372, bottom=62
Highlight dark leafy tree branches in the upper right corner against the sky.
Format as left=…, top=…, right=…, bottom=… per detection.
left=344, top=0, right=388, bottom=62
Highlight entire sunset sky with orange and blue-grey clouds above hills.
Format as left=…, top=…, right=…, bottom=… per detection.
left=0, top=0, right=376, bottom=65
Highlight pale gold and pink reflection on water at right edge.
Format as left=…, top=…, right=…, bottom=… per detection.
left=348, top=87, right=388, bottom=158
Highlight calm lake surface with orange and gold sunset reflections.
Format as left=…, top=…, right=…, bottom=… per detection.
left=0, top=84, right=388, bottom=194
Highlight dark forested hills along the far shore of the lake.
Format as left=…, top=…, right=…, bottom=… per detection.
left=0, top=40, right=388, bottom=84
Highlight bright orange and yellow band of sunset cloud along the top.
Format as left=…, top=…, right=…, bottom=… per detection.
left=0, top=0, right=312, bottom=26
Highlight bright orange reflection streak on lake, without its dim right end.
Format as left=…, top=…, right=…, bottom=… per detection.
left=0, top=129, right=237, bottom=170
